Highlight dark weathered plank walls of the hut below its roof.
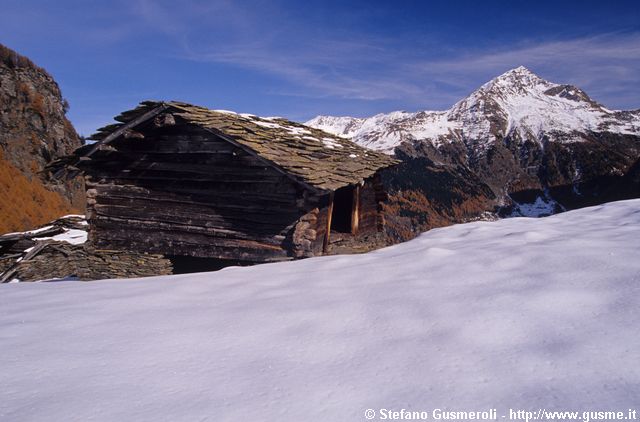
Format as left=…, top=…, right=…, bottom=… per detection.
left=81, top=121, right=384, bottom=262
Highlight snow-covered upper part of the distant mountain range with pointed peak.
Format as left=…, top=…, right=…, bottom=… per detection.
left=306, top=66, right=640, bottom=153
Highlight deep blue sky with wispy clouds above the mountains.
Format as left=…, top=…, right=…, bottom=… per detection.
left=0, top=0, right=640, bottom=135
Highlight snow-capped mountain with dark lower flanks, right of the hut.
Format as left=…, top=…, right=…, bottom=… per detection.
left=307, top=67, right=640, bottom=227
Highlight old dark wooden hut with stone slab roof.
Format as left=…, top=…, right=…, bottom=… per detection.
left=54, top=101, right=395, bottom=263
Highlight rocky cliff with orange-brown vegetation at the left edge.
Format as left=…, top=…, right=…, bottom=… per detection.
left=0, top=45, right=84, bottom=233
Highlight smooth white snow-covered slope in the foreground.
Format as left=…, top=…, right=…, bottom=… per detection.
left=0, top=200, right=640, bottom=421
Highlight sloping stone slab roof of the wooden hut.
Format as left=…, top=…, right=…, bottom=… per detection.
left=89, top=101, right=397, bottom=191
